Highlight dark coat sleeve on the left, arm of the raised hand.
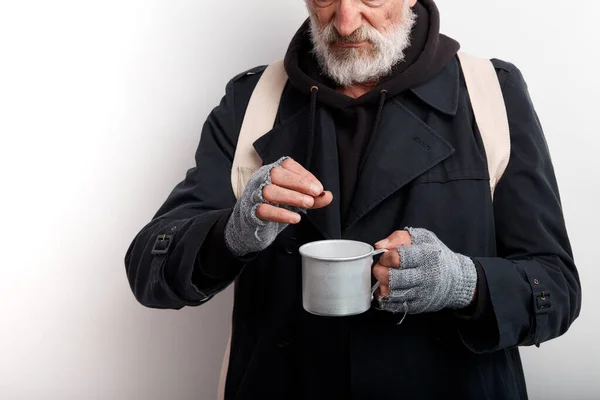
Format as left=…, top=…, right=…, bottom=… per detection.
left=125, top=71, right=258, bottom=309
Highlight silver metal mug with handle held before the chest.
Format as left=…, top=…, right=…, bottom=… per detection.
left=299, top=240, right=387, bottom=317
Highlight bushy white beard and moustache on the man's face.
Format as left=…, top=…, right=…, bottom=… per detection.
left=309, top=1, right=417, bottom=87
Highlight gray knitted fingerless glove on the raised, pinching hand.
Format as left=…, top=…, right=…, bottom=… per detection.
left=225, top=157, right=306, bottom=257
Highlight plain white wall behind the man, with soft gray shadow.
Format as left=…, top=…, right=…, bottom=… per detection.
left=0, top=0, right=600, bottom=400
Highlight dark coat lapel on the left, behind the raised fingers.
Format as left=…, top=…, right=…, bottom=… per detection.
left=254, top=95, right=341, bottom=239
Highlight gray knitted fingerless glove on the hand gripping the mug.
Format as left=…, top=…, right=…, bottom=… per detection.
left=379, top=228, right=477, bottom=314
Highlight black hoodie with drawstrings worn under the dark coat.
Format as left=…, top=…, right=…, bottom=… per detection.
left=285, top=0, right=460, bottom=223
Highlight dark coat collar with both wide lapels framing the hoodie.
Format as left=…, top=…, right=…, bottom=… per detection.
left=254, top=58, right=460, bottom=239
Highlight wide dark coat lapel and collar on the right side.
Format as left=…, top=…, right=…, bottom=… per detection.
left=343, top=58, right=460, bottom=232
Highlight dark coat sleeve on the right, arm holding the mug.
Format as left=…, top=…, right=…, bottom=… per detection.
left=460, top=62, right=581, bottom=352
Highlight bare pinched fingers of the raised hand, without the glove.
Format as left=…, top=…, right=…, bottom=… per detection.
left=256, top=158, right=333, bottom=224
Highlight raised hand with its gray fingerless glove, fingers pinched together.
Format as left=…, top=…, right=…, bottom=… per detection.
left=225, top=157, right=333, bottom=256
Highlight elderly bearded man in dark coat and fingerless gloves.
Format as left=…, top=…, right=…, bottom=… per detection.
left=125, top=0, right=581, bottom=400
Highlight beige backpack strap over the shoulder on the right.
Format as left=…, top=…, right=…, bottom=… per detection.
left=458, top=52, right=510, bottom=198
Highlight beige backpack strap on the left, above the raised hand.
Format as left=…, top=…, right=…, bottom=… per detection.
left=231, top=60, right=288, bottom=198
